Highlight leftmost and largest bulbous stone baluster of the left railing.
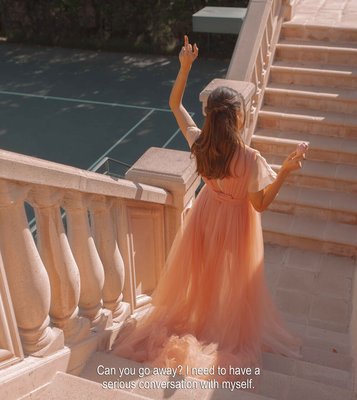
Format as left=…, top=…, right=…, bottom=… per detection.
left=0, top=180, right=64, bottom=357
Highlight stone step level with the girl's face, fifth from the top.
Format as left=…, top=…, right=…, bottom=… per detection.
left=257, top=106, right=357, bottom=139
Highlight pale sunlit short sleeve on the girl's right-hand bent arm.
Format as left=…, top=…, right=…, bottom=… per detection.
left=248, top=151, right=277, bottom=193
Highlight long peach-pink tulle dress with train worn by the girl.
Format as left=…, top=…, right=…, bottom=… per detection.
left=112, top=128, right=300, bottom=379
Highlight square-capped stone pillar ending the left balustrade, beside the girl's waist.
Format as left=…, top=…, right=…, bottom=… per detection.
left=125, top=147, right=200, bottom=256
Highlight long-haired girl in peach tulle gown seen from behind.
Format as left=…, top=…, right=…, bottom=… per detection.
left=113, top=36, right=304, bottom=380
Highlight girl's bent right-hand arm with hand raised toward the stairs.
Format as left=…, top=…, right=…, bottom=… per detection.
left=249, top=151, right=305, bottom=212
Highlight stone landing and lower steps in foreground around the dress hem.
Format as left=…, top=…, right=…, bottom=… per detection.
left=21, top=245, right=355, bottom=400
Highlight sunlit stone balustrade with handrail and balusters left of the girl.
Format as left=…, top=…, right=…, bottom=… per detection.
left=0, top=149, right=198, bottom=366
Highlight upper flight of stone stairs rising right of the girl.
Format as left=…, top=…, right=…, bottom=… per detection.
left=252, top=22, right=357, bottom=256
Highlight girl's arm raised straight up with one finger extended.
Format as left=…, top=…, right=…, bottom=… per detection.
left=169, top=35, right=198, bottom=140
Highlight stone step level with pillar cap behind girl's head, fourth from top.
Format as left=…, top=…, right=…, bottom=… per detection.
left=264, top=83, right=357, bottom=114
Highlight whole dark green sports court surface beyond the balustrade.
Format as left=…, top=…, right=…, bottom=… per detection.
left=0, top=43, right=228, bottom=169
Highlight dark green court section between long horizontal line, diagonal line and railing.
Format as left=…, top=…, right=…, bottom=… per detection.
left=0, top=94, right=145, bottom=169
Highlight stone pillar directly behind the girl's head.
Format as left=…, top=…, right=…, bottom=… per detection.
left=200, top=79, right=256, bottom=146
